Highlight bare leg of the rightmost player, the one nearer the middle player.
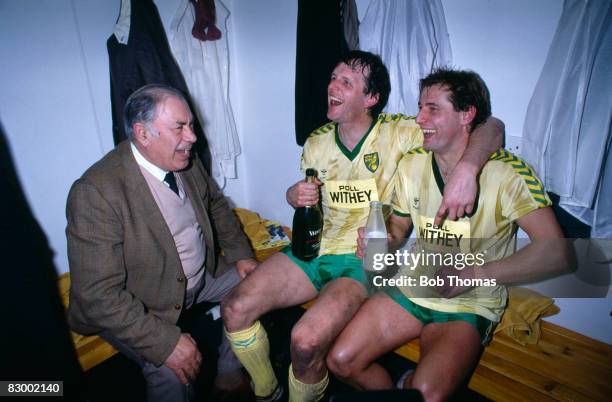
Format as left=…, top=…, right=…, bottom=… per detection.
left=327, top=293, right=423, bottom=390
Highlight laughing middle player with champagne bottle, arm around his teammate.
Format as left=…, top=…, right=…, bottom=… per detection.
left=222, top=51, right=503, bottom=401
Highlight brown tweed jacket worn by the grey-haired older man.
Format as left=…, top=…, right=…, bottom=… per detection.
left=66, top=141, right=253, bottom=365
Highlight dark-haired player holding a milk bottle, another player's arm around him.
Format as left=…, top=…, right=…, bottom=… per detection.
left=327, top=70, right=571, bottom=401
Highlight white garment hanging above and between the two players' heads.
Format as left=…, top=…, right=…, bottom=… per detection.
left=359, top=0, right=452, bottom=116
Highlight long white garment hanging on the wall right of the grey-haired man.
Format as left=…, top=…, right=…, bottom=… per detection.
left=170, top=0, right=240, bottom=187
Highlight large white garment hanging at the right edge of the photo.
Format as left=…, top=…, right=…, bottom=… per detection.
left=522, top=0, right=612, bottom=238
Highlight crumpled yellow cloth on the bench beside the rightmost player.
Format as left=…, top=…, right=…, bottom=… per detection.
left=495, top=287, right=560, bottom=345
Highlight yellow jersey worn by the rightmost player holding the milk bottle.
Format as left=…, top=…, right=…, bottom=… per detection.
left=392, top=148, right=552, bottom=322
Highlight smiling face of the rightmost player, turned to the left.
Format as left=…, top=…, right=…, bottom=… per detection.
left=416, top=85, right=471, bottom=154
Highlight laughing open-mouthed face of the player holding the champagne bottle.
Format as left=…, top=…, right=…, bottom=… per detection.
left=327, top=63, right=378, bottom=124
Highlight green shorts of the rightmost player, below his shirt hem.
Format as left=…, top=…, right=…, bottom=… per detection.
left=384, top=286, right=496, bottom=345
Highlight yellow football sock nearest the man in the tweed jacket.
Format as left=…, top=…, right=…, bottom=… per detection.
left=225, top=321, right=278, bottom=397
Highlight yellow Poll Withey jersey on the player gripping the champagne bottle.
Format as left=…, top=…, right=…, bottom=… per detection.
left=301, top=113, right=423, bottom=255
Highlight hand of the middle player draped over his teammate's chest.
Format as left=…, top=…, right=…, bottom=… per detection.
left=434, top=163, right=478, bottom=226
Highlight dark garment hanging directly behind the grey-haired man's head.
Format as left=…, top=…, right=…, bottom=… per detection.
left=106, top=0, right=210, bottom=171
